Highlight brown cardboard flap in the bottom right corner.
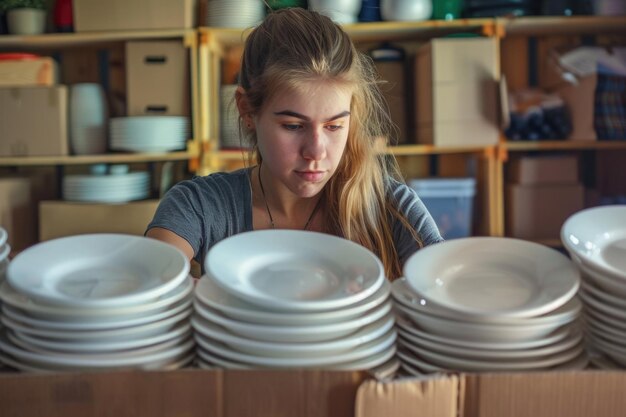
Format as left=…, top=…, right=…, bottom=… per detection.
left=459, top=370, right=626, bottom=417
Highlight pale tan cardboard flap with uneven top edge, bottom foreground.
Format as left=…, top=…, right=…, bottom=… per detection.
left=354, top=375, right=460, bottom=417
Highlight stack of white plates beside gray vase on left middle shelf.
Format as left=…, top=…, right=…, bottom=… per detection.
left=109, top=116, right=189, bottom=152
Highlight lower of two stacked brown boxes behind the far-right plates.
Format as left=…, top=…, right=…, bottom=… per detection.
left=506, top=184, right=585, bottom=240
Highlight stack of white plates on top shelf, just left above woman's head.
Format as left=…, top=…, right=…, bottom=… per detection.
left=205, top=0, right=265, bottom=28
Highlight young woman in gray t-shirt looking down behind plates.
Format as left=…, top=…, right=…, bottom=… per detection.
left=146, top=8, right=442, bottom=279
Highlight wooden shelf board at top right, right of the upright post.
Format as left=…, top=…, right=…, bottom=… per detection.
left=496, top=16, right=626, bottom=36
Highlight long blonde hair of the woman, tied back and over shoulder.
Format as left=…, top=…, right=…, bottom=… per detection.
left=240, top=8, right=422, bottom=279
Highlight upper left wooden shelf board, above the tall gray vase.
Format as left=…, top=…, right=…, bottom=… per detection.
left=0, top=29, right=195, bottom=50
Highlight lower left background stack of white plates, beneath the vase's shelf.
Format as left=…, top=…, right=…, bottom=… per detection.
left=63, top=171, right=150, bottom=203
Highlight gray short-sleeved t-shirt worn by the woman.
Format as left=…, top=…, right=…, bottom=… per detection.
left=147, top=168, right=443, bottom=265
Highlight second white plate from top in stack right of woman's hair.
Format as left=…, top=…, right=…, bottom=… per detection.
left=395, top=304, right=569, bottom=343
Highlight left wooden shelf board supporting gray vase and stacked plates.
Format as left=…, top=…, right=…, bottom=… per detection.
left=0, top=151, right=198, bottom=166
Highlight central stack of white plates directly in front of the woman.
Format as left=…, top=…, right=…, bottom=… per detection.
left=192, top=230, right=399, bottom=377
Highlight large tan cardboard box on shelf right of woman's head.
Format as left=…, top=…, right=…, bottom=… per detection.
left=414, top=38, right=500, bottom=147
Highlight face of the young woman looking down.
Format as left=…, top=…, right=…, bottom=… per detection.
left=254, top=81, right=352, bottom=197
